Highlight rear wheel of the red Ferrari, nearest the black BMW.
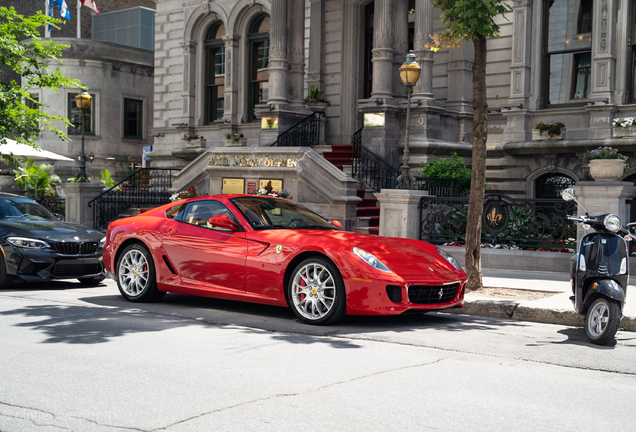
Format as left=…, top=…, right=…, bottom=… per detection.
left=115, top=243, right=166, bottom=303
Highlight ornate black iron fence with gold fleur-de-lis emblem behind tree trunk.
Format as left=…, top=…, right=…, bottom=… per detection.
left=420, top=194, right=577, bottom=249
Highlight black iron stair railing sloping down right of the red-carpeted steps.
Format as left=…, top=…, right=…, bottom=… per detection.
left=351, top=129, right=400, bottom=192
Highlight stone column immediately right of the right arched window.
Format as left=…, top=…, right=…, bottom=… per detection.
left=268, top=0, right=288, bottom=109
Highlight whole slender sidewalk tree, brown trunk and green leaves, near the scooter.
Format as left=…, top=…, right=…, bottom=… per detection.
left=429, top=0, right=510, bottom=289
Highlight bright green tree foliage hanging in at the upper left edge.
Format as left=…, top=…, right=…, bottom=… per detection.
left=0, top=7, right=85, bottom=146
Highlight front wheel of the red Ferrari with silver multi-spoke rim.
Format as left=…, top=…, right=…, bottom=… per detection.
left=287, top=257, right=347, bottom=325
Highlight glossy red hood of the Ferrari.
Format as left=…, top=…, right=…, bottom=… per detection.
left=246, top=230, right=456, bottom=275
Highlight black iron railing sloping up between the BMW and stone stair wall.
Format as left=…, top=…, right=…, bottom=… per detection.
left=88, top=168, right=179, bottom=230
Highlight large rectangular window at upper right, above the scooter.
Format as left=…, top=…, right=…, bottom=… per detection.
left=541, top=0, right=594, bottom=108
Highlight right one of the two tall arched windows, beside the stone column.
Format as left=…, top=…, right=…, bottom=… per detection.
left=247, top=15, right=270, bottom=120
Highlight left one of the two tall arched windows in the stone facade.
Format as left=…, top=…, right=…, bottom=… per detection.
left=204, top=23, right=225, bottom=124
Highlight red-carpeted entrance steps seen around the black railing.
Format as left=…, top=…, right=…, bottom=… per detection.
left=322, top=144, right=380, bottom=235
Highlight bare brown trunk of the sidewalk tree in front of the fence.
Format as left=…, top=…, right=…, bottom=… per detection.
left=465, top=36, right=488, bottom=290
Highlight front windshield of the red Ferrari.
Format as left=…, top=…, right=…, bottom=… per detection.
left=231, top=196, right=336, bottom=230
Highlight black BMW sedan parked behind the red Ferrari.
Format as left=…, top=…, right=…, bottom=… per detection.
left=0, top=193, right=106, bottom=288
